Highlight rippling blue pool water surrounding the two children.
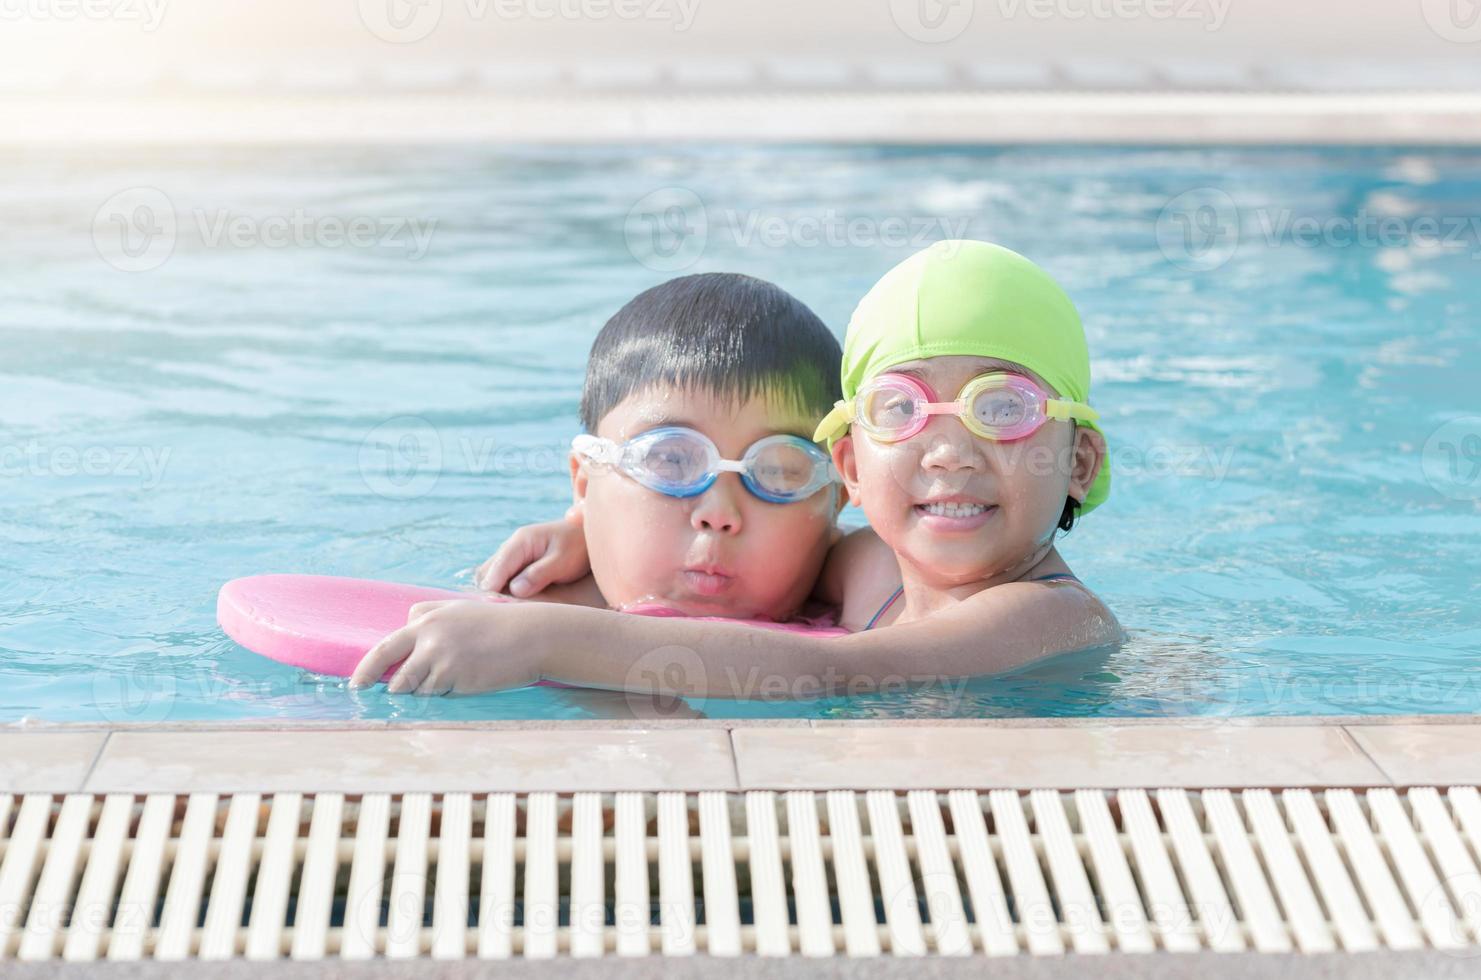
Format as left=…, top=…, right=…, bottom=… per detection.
left=0, top=147, right=1481, bottom=722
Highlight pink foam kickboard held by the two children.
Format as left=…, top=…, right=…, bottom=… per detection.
left=216, top=574, right=847, bottom=687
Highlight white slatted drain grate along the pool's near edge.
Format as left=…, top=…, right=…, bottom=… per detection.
left=0, top=786, right=1481, bottom=961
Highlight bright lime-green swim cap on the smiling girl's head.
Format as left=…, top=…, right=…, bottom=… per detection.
left=818, top=241, right=1111, bottom=514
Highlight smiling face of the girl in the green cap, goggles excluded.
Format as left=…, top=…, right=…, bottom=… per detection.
left=834, top=355, right=1105, bottom=588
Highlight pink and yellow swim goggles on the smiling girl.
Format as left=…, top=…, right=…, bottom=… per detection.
left=815, top=372, right=1100, bottom=443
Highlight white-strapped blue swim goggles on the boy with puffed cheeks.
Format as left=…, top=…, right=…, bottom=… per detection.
left=570, top=425, right=834, bottom=503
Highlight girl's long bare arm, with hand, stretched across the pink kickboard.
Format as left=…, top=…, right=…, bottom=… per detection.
left=351, top=582, right=1121, bottom=700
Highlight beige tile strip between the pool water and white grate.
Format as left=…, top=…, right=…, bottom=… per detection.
left=0, top=715, right=1481, bottom=793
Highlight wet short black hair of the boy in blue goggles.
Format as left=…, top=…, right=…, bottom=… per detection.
left=581, top=272, right=843, bottom=435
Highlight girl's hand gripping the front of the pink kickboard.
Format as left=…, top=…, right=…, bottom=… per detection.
left=350, top=600, right=541, bottom=694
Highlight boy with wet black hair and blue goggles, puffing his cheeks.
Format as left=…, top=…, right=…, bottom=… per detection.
left=480, top=274, right=841, bottom=622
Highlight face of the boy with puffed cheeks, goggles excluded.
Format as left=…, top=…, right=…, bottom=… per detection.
left=572, top=386, right=841, bottom=619
